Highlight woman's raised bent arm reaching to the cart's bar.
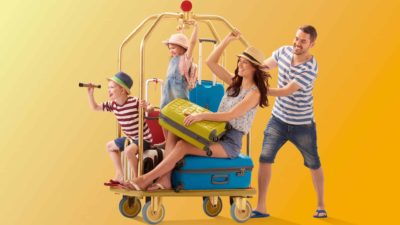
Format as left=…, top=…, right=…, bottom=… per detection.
left=206, top=30, right=240, bottom=85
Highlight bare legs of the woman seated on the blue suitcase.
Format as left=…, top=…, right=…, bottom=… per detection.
left=133, top=140, right=228, bottom=190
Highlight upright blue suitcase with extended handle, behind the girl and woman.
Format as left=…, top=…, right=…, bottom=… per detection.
left=189, top=39, right=225, bottom=112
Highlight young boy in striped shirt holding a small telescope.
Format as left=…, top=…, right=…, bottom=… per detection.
left=88, top=72, right=153, bottom=186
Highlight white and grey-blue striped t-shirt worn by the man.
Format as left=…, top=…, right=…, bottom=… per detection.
left=272, top=46, right=318, bottom=125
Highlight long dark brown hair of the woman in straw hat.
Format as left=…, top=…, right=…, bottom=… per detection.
left=226, top=59, right=271, bottom=107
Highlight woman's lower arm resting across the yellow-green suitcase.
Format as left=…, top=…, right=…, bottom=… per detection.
left=183, top=91, right=260, bottom=126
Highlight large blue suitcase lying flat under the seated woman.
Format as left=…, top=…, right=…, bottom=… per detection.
left=171, top=154, right=253, bottom=191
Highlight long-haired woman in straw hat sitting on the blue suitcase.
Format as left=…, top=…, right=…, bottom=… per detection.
left=128, top=30, right=270, bottom=190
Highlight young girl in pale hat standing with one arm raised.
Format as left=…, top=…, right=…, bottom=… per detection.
left=150, top=22, right=199, bottom=190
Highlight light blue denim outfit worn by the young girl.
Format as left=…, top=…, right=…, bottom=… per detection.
left=160, top=74, right=189, bottom=109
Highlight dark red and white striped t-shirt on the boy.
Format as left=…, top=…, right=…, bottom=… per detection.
left=102, top=96, right=152, bottom=143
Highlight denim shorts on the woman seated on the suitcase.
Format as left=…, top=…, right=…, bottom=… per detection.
left=217, top=128, right=243, bottom=158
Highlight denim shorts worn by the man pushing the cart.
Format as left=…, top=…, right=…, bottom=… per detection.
left=260, top=116, right=321, bottom=169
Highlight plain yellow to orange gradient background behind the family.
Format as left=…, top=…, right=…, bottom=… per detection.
left=0, top=0, right=400, bottom=225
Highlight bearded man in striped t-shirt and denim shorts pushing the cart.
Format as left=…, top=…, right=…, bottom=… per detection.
left=252, top=25, right=327, bottom=218
